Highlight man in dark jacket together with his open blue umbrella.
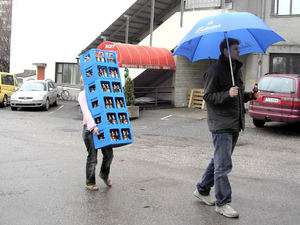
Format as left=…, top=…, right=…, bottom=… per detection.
left=174, top=12, right=284, bottom=217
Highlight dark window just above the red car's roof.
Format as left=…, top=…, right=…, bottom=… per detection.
left=270, top=53, right=300, bottom=74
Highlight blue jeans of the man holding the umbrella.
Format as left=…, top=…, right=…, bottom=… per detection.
left=197, top=132, right=239, bottom=206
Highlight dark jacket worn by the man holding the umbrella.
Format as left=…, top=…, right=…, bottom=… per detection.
left=204, top=56, right=252, bottom=133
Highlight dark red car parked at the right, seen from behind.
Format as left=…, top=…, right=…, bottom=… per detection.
left=249, top=74, right=300, bottom=127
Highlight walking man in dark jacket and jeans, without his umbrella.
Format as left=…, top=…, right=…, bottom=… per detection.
left=194, top=38, right=257, bottom=217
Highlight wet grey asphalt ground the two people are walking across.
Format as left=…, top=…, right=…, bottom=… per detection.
left=0, top=103, right=300, bottom=225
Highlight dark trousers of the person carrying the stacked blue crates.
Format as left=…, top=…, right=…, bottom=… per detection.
left=82, top=125, right=114, bottom=185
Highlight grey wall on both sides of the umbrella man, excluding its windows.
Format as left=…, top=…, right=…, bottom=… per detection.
left=174, top=0, right=300, bottom=107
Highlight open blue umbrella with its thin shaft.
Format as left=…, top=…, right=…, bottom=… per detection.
left=174, top=12, right=284, bottom=85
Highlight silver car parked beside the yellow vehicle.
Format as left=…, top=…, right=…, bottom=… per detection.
left=10, top=80, right=58, bottom=111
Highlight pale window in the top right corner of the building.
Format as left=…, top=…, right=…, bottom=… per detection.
left=273, top=0, right=300, bottom=16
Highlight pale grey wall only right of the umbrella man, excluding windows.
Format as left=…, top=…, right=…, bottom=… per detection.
left=233, top=0, right=300, bottom=89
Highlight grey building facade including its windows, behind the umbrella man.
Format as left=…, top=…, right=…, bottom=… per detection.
left=173, top=0, right=300, bottom=107
